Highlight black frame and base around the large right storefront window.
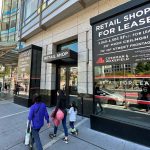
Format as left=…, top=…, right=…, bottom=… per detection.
left=90, top=0, right=150, bottom=146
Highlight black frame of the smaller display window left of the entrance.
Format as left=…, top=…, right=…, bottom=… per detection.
left=14, top=45, right=42, bottom=107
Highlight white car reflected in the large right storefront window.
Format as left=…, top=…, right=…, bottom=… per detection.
left=96, top=89, right=125, bottom=105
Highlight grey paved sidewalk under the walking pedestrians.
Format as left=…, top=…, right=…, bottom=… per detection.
left=0, top=101, right=150, bottom=150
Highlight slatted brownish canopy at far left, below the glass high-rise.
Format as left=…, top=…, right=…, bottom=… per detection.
left=0, top=42, right=18, bottom=65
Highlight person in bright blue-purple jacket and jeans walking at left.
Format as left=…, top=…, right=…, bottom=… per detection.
left=28, top=94, right=50, bottom=150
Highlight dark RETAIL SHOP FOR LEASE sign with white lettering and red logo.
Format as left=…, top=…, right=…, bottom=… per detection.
left=92, top=4, right=150, bottom=65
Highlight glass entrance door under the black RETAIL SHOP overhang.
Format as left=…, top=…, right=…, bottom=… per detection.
left=58, top=66, right=78, bottom=105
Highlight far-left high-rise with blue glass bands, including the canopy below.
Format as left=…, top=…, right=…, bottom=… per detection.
left=0, top=0, right=19, bottom=66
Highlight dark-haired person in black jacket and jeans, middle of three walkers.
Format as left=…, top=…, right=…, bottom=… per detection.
left=49, top=90, right=68, bottom=143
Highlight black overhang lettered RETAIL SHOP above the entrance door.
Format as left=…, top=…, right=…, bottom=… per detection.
left=43, top=49, right=78, bottom=64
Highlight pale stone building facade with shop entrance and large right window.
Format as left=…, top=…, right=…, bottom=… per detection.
left=16, top=0, right=150, bottom=145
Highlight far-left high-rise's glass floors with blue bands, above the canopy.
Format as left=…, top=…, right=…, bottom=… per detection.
left=0, top=0, right=18, bottom=42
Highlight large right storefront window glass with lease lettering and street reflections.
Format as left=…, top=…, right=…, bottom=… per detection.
left=91, top=0, right=150, bottom=128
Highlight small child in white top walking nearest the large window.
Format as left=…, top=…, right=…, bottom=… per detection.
left=68, top=101, right=78, bottom=135
